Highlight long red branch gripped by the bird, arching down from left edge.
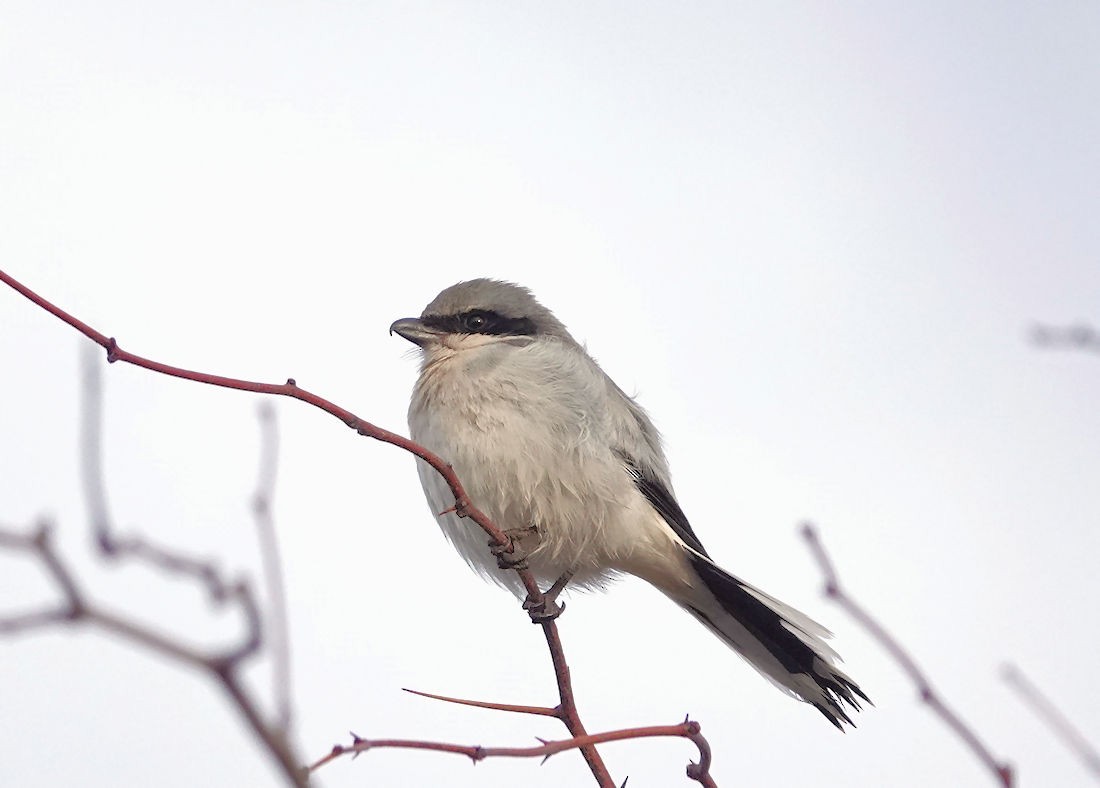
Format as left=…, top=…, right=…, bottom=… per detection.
left=0, top=271, right=712, bottom=788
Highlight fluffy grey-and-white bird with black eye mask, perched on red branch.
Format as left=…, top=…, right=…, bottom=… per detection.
left=389, top=278, right=870, bottom=731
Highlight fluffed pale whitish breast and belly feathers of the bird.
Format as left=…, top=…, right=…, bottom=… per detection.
left=409, top=341, right=644, bottom=588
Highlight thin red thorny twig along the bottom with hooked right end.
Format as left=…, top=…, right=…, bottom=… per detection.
left=309, top=720, right=715, bottom=788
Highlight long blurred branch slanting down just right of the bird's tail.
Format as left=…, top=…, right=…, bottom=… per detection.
left=802, top=523, right=1014, bottom=788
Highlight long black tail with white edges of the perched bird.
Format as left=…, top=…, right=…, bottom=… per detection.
left=677, top=554, right=871, bottom=731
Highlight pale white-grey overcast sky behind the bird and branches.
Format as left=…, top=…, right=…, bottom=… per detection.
left=0, top=0, right=1100, bottom=788
